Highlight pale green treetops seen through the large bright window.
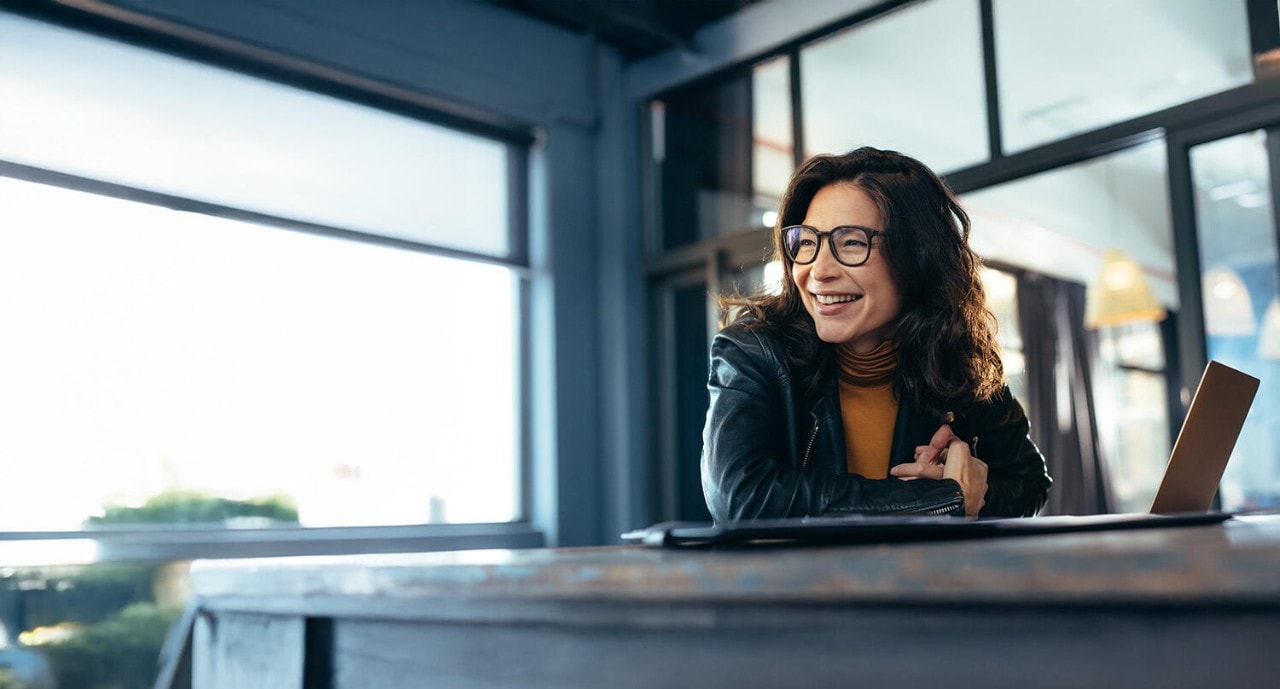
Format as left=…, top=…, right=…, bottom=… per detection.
left=88, top=490, right=298, bottom=526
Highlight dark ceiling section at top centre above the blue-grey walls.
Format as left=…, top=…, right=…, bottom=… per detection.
left=490, top=0, right=763, bottom=59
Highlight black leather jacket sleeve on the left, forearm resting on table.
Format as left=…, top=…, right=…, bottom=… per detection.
left=701, top=333, right=964, bottom=523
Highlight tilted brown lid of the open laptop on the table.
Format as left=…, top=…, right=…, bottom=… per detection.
left=1151, top=361, right=1258, bottom=515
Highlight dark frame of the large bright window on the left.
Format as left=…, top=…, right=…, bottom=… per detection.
left=0, top=4, right=548, bottom=553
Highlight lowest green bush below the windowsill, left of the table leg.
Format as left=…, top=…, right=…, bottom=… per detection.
left=40, top=603, right=182, bottom=689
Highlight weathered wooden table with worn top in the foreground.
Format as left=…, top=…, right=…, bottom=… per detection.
left=192, top=516, right=1280, bottom=689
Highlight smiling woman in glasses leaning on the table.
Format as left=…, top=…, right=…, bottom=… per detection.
left=701, top=147, right=1051, bottom=521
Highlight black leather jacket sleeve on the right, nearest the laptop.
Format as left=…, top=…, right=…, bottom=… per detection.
left=974, top=387, right=1052, bottom=516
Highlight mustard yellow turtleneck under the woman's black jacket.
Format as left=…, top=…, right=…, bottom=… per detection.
left=836, top=341, right=897, bottom=479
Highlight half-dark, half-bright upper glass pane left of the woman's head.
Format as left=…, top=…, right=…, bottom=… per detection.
left=653, top=58, right=795, bottom=248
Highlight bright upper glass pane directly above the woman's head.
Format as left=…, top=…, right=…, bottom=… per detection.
left=800, top=0, right=989, bottom=172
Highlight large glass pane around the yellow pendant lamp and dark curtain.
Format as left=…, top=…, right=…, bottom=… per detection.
left=963, top=141, right=1178, bottom=512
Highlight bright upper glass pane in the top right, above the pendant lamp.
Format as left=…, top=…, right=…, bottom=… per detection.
left=993, top=0, right=1252, bottom=152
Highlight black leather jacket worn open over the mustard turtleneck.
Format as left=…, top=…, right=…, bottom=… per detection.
left=701, top=324, right=1051, bottom=521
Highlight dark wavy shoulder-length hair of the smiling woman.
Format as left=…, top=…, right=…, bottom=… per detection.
left=721, top=147, right=1005, bottom=415
